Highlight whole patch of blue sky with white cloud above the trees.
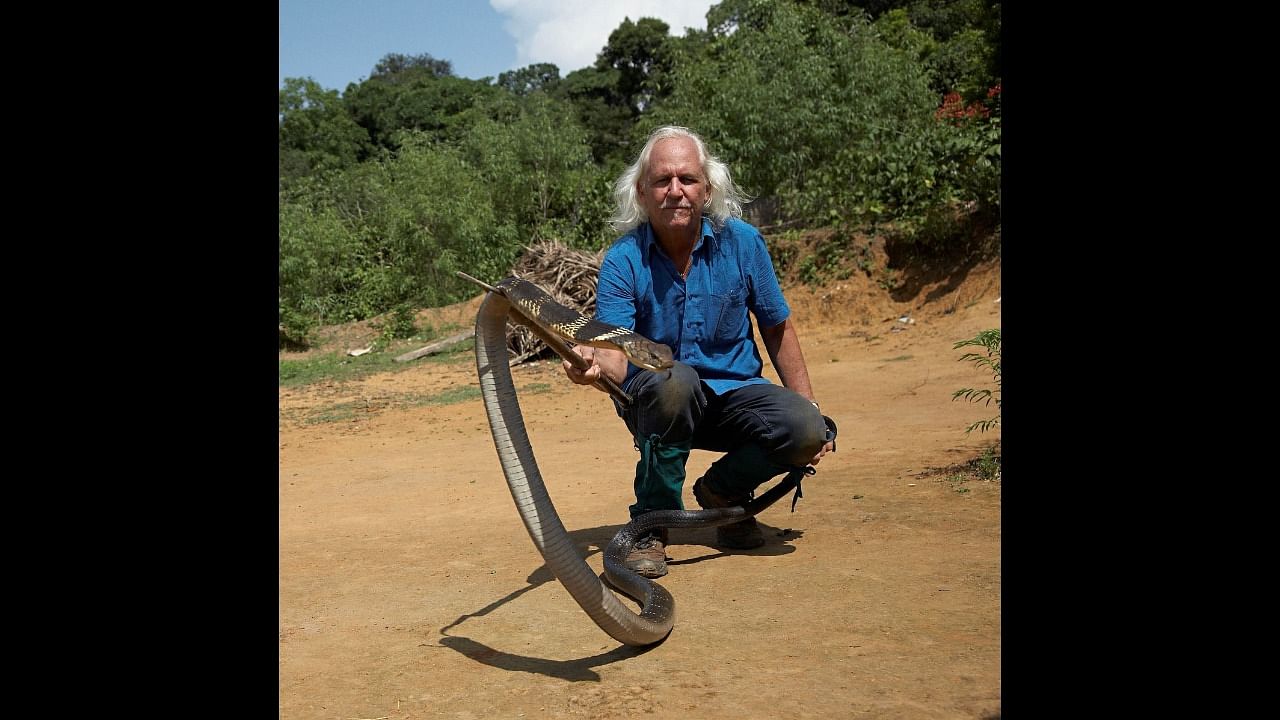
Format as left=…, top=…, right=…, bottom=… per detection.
left=279, top=0, right=713, bottom=92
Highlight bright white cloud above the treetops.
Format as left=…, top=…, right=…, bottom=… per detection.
left=489, top=0, right=718, bottom=77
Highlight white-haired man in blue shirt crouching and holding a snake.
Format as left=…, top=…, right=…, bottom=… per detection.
left=563, top=126, right=833, bottom=578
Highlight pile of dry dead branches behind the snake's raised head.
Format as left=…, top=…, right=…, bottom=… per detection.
left=507, top=240, right=604, bottom=365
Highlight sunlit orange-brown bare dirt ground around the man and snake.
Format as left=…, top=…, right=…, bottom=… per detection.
left=279, top=254, right=1001, bottom=720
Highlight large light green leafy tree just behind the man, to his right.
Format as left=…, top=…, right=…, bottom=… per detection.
left=641, top=0, right=934, bottom=208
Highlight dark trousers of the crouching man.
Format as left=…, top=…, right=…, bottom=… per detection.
left=614, top=363, right=827, bottom=507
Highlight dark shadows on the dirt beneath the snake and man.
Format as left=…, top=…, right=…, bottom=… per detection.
left=439, top=523, right=804, bottom=683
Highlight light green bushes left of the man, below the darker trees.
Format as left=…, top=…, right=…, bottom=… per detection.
left=280, top=84, right=612, bottom=336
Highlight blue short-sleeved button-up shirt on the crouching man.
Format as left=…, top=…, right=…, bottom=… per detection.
left=595, top=218, right=791, bottom=395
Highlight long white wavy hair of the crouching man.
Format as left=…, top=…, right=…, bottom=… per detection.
left=609, top=126, right=750, bottom=233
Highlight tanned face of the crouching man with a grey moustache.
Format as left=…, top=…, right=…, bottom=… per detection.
left=636, top=137, right=709, bottom=237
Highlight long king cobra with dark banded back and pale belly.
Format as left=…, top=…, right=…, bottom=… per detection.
left=457, top=272, right=819, bottom=646
